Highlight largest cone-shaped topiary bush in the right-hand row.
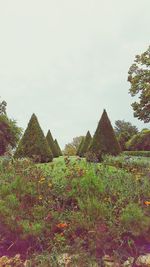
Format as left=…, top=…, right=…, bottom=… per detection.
left=89, top=110, right=121, bottom=161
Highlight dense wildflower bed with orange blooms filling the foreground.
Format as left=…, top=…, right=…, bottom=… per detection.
left=0, top=157, right=150, bottom=267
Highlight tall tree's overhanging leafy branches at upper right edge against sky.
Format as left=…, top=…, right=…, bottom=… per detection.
left=128, top=46, right=150, bottom=123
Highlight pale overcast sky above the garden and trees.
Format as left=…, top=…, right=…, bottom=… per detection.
left=0, top=0, right=150, bottom=148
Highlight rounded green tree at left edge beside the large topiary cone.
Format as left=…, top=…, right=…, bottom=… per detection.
left=0, top=115, right=22, bottom=155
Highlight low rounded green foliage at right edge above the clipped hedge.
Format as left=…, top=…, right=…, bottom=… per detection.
left=126, top=130, right=150, bottom=151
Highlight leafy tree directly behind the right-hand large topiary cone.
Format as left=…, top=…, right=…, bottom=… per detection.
left=114, top=120, right=138, bottom=150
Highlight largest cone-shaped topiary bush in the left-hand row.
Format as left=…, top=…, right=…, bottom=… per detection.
left=15, top=114, right=53, bottom=162
